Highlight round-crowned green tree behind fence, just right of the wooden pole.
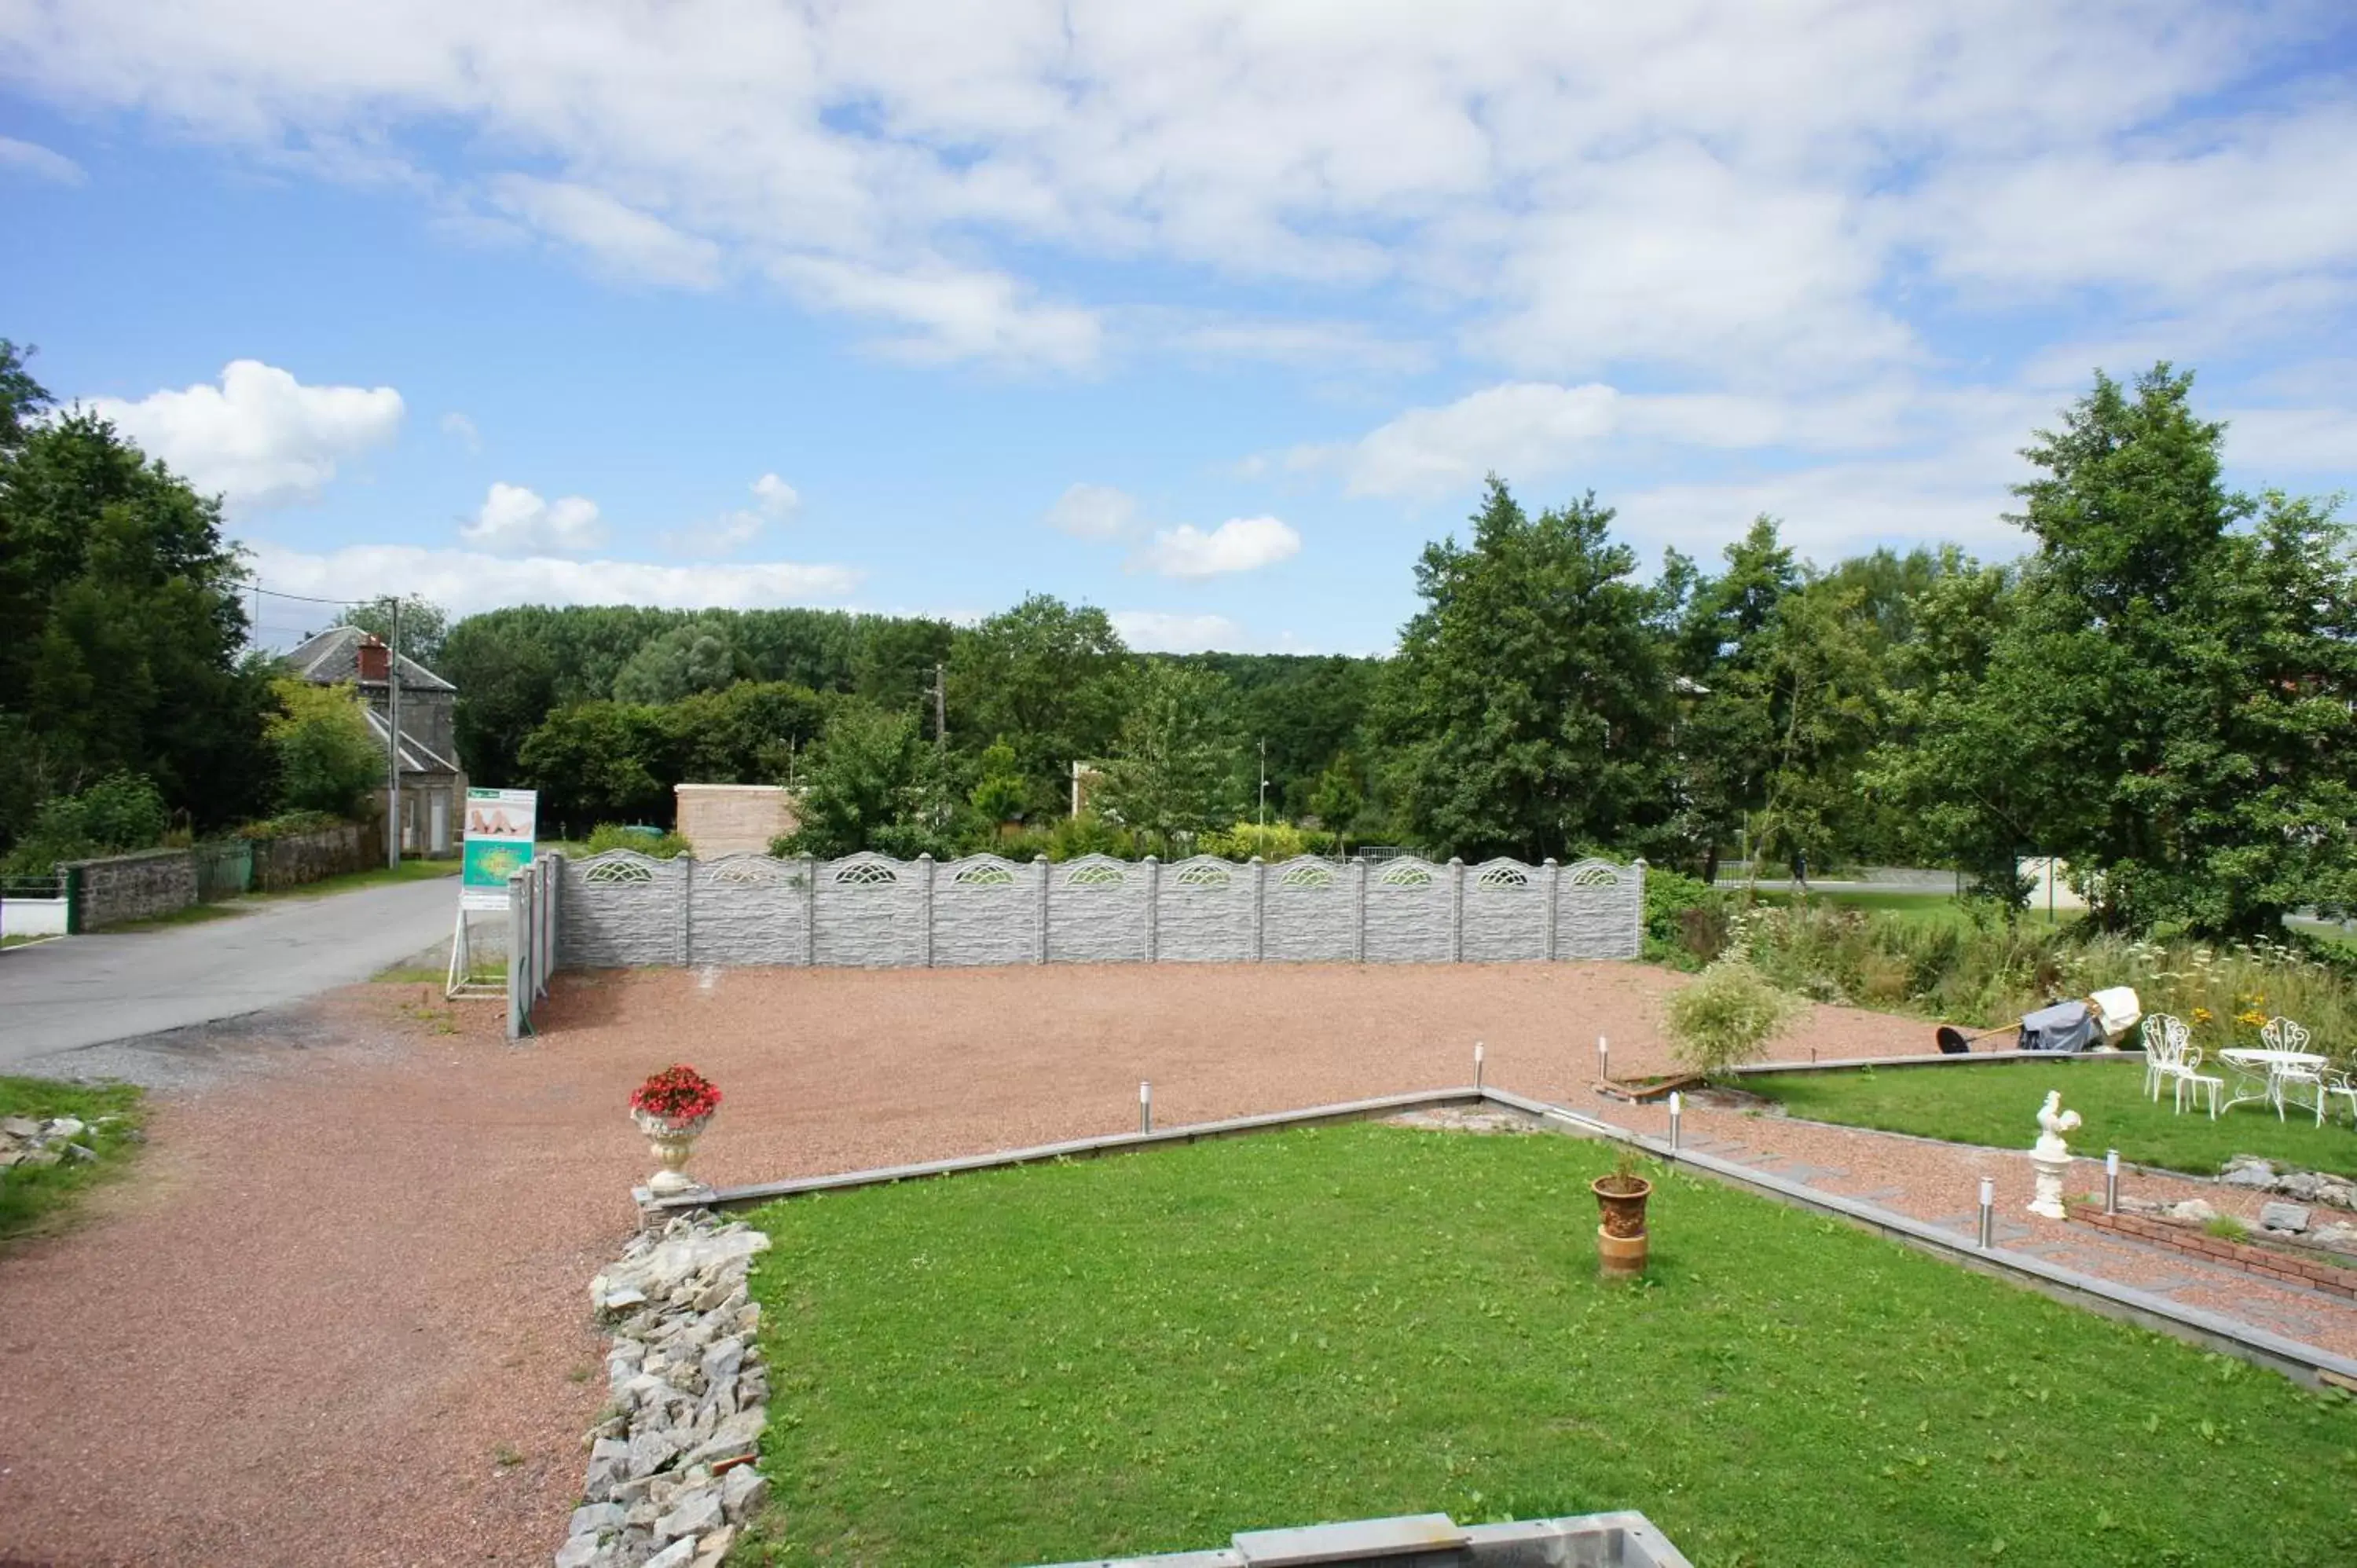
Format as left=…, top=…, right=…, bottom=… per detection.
left=943, top=594, right=1129, bottom=809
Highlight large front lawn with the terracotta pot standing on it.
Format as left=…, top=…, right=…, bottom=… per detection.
left=731, top=1127, right=2357, bottom=1568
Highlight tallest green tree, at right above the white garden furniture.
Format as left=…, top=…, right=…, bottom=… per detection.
left=1886, top=363, right=2357, bottom=934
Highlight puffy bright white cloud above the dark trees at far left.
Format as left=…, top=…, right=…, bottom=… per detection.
left=90, top=358, right=403, bottom=509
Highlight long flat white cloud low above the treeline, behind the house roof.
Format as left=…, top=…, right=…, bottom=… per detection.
left=250, top=542, right=860, bottom=615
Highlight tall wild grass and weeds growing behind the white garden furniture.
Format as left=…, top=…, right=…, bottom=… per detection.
left=1728, top=903, right=2357, bottom=1066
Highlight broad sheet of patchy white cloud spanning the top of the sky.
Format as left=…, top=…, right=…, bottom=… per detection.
left=0, top=0, right=2357, bottom=410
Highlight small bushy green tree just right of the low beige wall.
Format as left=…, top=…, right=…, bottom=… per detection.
left=780, top=698, right=955, bottom=859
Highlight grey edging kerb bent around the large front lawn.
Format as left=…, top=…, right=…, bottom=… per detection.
left=634, top=1070, right=2357, bottom=1391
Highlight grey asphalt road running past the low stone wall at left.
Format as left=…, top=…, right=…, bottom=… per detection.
left=0, top=877, right=457, bottom=1071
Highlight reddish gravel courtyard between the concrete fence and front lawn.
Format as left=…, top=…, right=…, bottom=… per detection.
left=0, top=965, right=1930, bottom=1568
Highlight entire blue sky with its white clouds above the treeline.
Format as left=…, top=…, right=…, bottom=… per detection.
left=0, top=0, right=2357, bottom=653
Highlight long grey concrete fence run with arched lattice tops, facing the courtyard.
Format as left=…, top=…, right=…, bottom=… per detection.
left=556, top=849, right=1645, bottom=969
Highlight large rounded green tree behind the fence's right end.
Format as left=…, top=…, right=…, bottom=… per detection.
left=1376, top=476, right=1671, bottom=859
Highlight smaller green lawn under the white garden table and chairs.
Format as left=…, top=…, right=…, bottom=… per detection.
left=1742, top=1057, right=2357, bottom=1177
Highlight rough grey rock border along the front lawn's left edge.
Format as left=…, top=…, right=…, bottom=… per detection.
left=556, top=1212, right=768, bottom=1568
